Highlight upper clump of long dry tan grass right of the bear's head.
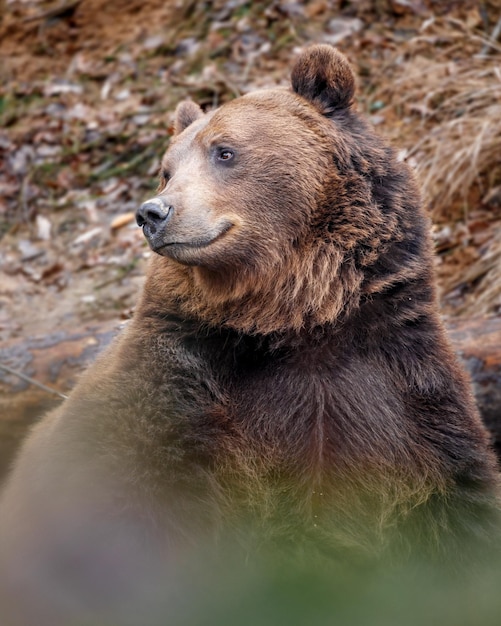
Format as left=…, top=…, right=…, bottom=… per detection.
left=378, top=19, right=501, bottom=219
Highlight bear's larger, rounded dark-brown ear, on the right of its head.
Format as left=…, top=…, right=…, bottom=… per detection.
left=291, top=44, right=355, bottom=115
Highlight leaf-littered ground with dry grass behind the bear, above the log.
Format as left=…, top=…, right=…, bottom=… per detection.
left=0, top=0, right=501, bottom=343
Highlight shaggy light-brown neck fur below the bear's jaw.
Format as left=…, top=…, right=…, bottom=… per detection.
left=136, top=246, right=363, bottom=335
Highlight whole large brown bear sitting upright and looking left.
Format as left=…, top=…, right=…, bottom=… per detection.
left=0, top=45, right=498, bottom=625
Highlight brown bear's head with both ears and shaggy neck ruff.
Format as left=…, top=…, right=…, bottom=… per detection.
left=137, top=45, right=428, bottom=333
